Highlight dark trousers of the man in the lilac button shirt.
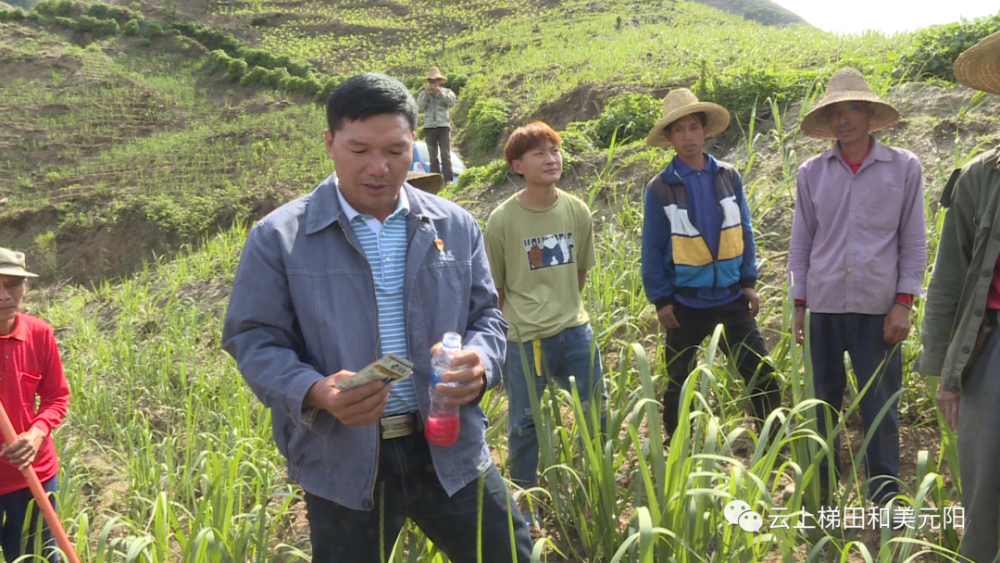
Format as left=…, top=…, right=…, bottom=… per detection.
left=809, top=313, right=903, bottom=503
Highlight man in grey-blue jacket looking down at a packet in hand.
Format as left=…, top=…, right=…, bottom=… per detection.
left=222, top=73, right=531, bottom=563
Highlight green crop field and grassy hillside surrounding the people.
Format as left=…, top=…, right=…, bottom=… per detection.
left=0, top=0, right=1000, bottom=563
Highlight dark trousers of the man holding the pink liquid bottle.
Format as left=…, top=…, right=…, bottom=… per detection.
left=305, top=433, right=532, bottom=563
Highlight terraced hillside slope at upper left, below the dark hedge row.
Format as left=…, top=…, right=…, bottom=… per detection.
left=0, top=19, right=328, bottom=280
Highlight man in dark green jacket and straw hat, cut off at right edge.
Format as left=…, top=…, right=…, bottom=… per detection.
left=916, top=33, right=1000, bottom=563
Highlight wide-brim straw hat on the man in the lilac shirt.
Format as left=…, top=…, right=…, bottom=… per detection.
left=802, top=67, right=901, bottom=140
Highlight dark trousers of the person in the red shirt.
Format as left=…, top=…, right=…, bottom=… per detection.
left=0, top=477, right=59, bottom=563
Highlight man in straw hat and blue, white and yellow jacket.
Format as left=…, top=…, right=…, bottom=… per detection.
left=642, top=88, right=781, bottom=446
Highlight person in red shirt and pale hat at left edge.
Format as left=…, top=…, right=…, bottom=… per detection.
left=0, top=248, right=69, bottom=563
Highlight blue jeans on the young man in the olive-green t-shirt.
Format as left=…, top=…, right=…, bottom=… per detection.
left=503, top=323, right=608, bottom=489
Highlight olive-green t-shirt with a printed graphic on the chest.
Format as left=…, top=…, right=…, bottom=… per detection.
left=484, top=188, right=596, bottom=342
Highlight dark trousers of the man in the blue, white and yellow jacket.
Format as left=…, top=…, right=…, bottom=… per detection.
left=663, top=296, right=781, bottom=436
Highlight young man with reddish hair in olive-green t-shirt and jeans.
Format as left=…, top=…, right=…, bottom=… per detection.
left=485, top=121, right=607, bottom=537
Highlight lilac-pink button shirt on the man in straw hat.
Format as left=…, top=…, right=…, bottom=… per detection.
left=788, top=141, right=927, bottom=315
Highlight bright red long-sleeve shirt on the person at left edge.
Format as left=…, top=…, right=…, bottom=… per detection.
left=0, top=313, right=69, bottom=495
